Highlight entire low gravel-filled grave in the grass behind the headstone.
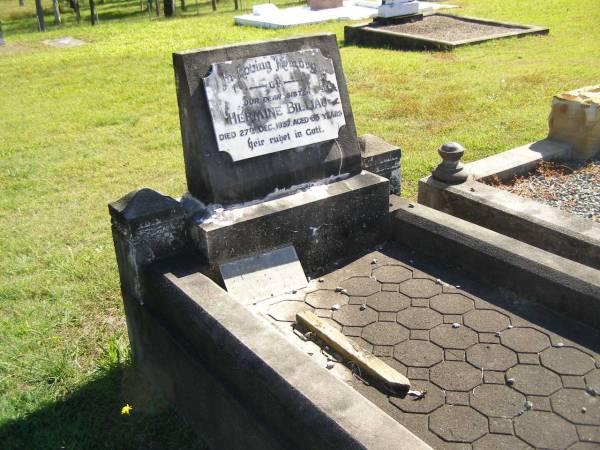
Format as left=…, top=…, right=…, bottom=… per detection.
left=344, top=13, right=549, bottom=50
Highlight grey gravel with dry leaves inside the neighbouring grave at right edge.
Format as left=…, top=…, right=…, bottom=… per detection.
left=492, top=159, right=600, bottom=222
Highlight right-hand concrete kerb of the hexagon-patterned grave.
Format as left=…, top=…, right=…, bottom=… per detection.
left=391, top=199, right=600, bottom=329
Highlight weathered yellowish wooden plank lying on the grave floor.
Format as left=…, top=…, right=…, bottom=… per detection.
left=296, top=311, right=410, bottom=393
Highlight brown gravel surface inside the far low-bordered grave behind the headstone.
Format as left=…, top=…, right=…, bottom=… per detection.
left=381, top=15, right=525, bottom=42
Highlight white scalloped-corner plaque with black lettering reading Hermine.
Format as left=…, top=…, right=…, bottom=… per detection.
left=204, top=49, right=346, bottom=161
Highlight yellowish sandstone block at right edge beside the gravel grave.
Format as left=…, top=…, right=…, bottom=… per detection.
left=548, top=85, right=600, bottom=159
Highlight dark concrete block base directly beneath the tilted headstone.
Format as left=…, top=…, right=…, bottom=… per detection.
left=189, top=171, right=390, bottom=274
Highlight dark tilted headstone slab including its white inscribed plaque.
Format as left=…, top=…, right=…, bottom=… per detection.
left=173, top=34, right=361, bottom=204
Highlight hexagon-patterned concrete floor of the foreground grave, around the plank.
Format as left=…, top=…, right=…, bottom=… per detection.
left=254, top=245, right=600, bottom=449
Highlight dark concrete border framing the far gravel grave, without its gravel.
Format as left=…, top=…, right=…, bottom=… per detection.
left=344, top=13, right=550, bottom=50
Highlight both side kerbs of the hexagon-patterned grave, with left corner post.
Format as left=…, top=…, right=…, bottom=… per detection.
left=109, top=189, right=600, bottom=450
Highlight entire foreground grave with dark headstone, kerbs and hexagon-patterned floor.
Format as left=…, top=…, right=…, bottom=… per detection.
left=109, top=34, right=600, bottom=450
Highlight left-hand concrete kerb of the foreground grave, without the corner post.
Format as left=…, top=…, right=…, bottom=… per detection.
left=138, top=258, right=430, bottom=450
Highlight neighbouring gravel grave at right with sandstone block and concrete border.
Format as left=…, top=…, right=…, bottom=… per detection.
left=419, top=86, right=600, bottom=269
